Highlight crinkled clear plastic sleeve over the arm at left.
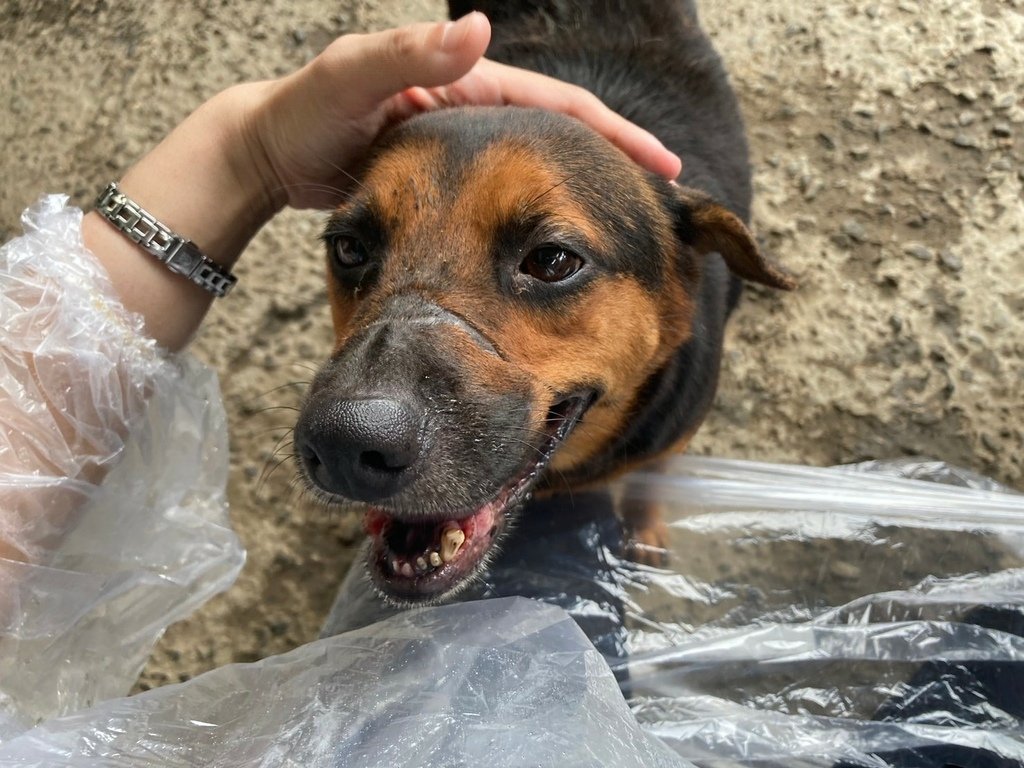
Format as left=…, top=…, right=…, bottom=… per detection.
left=0, top=196, right=244, bottom=741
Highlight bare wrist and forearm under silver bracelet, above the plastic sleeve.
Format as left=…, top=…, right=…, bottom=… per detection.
left=82, top=84, right=285, bottom=351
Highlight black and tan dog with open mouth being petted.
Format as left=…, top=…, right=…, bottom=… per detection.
left=296, top=0, right=793, bottom=602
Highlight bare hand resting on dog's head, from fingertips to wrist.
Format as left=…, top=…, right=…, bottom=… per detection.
left=232, top=12, right=680, bottom=208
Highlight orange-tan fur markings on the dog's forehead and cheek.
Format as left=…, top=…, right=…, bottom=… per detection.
left=330, top=133, right=693, bottom=481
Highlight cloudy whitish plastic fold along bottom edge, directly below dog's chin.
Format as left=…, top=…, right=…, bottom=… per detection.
left=0, top=598, right=690, bottom=768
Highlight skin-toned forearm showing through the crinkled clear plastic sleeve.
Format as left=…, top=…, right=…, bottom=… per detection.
left=0, top=196, right=176, bottom=561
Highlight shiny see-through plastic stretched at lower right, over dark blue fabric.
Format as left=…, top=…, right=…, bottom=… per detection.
left=325, top=457, right=1024, bottom=768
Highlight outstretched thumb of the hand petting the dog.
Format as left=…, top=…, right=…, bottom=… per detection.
left=337, top=11, right=490, bottom=106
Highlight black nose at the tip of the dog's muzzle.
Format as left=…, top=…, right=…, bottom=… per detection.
left=295, top=399, right=423, bottom=502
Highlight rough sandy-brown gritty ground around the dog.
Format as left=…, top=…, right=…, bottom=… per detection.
left=0, top=0, right=1024, bottom=687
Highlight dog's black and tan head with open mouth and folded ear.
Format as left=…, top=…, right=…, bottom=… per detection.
left=296, top=109, right=784, bottom=602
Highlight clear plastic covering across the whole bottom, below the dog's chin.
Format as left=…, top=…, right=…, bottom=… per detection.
left=0, top=458, right=1024, bottom=768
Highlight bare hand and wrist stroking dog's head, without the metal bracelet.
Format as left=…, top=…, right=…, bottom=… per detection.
left=83, top=13, right=680, bottom=349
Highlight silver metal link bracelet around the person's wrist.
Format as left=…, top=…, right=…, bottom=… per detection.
left=96, top=181, right=238, bottom=296
